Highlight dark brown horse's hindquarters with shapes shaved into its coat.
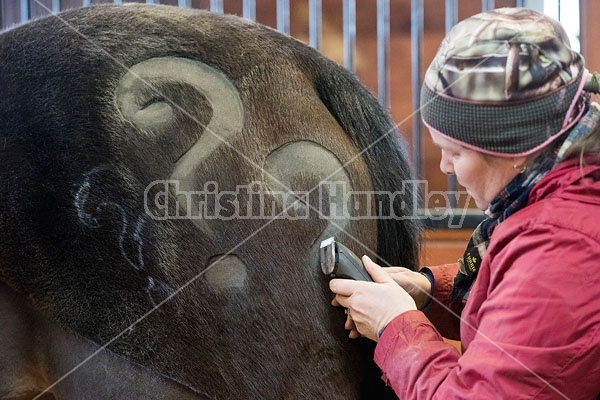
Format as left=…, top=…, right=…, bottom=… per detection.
left=0, top=4, right=419, bottom=399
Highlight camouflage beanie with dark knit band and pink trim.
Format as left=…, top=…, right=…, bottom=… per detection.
left=421, top=8, right=586, bottom=156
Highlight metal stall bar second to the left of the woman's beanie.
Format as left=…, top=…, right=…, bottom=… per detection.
left=377, top=0, right=390, bottom=109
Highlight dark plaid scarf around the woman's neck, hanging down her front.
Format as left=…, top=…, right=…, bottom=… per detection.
left=450, top=104, right=600, bottom=303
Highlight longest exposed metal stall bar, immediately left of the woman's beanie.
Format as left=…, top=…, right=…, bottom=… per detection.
left=410, top=0, right=423, bottom=179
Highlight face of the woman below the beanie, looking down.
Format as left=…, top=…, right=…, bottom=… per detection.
left=430, top=131, right=524, bottom=210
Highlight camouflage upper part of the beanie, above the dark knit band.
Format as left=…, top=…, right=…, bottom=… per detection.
left=425, top=8, right=583, bottom=102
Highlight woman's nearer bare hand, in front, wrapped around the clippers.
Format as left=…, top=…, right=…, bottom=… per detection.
left=329, top=256, right=417, bottom=341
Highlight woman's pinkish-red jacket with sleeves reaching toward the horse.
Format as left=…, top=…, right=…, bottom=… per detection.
left=375, top=160, right=600, bottom=400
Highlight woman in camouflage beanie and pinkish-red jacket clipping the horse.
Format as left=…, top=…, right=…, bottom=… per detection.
left=330, top=9, right=600, bottom=399
